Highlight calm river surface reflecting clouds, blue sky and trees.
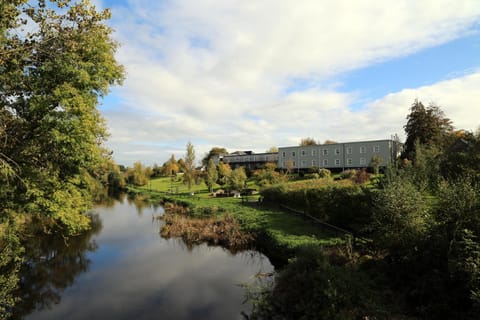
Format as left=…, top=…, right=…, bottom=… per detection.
left=22, top=199, right=273, bottom=320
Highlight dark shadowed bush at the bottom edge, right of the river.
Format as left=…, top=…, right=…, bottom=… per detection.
left=249, top=247, right=386, bottom=320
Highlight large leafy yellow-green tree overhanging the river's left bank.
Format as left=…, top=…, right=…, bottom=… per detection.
left=0, top=0, right=123, bottom=234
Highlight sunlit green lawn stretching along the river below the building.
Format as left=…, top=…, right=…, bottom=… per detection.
left=130, top=178, right=343, bottom=249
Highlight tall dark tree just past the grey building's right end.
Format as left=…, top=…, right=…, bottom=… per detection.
left=402, top=100, right=453, bottom=160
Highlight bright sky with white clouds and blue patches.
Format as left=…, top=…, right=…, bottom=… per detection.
left=93, top=0, right=480, bottom=166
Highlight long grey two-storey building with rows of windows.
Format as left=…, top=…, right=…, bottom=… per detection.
left=278, top=140, right=402, bottom=171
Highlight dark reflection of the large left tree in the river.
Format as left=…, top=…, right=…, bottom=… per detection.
left=13, top=215, right=102, bottom=319
